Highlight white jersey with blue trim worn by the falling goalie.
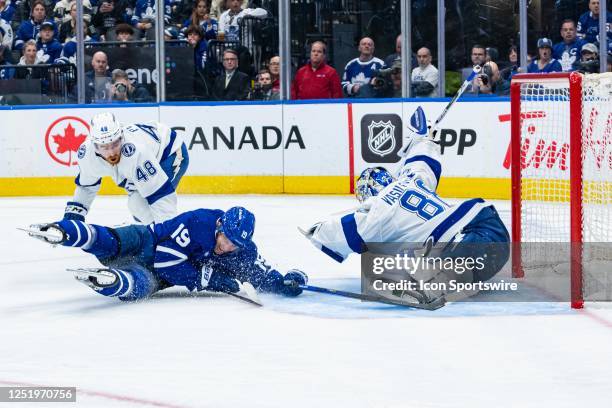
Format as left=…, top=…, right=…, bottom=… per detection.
left=309, top=139, right=488, bottom=262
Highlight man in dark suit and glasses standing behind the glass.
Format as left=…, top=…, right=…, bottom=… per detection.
left=213, top=49, right=251, bottom=101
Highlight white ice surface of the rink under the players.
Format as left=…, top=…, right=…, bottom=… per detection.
left=0, top=195, right=612, bottom=408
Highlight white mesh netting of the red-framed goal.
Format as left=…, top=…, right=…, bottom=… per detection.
left=520, top=74, right=612, bottom=300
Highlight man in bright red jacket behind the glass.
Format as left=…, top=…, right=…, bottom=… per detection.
left=291, top=41, right=342, bottom=99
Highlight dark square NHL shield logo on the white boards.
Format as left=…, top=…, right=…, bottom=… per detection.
left=361, top=114, right=402, bottom=163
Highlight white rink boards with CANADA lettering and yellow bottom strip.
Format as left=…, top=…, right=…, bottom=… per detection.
left=0, top=98, right=510, bottom=198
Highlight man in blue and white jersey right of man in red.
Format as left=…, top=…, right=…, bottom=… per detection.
left=342, top=37, right=385, bottom=96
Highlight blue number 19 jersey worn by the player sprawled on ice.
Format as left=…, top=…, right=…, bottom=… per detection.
left=149, top=209, right=262, bottom=290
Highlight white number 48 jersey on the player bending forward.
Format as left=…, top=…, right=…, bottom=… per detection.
left=73, top=122, right=183, bottom=222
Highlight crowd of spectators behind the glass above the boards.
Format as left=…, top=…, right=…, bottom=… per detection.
left=0, top=0, right=612, bottom=103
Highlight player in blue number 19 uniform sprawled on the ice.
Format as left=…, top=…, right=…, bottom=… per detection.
left=29, top=207, right=308, bottom=300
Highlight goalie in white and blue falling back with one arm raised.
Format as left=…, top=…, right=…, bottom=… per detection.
left=302, top=107, right=510, bottom=288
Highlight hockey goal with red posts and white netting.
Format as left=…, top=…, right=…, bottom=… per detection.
left=511, top=73, right=612, bottom=308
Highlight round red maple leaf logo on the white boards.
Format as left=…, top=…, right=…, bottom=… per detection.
left=45, top=116, right=89, bottom=166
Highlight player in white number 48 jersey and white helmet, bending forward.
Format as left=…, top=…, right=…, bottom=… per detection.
left=64, top=113, right=189, bottom=224
